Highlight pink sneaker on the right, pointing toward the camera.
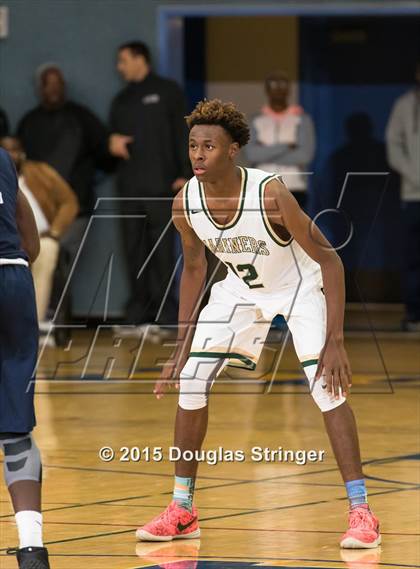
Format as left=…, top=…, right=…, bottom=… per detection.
left=340, top=506, right=381, bottom=549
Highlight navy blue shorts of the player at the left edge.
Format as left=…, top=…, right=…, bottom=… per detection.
left=0, top=265, right=38, bottom=433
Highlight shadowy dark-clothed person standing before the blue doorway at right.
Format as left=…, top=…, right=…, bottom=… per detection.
left=315, top=112, right=400, bottom=302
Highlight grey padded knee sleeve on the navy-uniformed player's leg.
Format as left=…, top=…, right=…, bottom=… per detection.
left=0, top=433, right=42, bottom=486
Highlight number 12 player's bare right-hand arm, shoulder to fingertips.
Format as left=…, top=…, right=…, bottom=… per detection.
left=264, top=180, right=351, bottom=399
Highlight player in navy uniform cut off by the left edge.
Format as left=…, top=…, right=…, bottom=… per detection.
left=0, top=148, right=50, bottom=569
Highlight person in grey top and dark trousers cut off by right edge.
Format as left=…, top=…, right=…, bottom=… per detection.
left=386, top=57, right=420, bottom=332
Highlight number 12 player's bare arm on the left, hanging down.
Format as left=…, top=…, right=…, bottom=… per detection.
left=154, top=191, right=207, bottom=399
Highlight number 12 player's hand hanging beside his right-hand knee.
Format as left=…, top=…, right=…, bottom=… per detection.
left=315, top=337, right=351, bottom=399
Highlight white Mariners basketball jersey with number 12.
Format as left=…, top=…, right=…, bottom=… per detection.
left=183, top=168, right=322, bottom=297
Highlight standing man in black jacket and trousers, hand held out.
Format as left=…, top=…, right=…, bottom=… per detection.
left=109, top=42, right=191, bottom=333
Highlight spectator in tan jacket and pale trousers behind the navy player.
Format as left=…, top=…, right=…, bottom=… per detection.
left=0, top=137, right=79, bottom=324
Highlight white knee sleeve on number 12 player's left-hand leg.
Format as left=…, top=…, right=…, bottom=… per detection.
left=179, top=357, right=220, bottom=411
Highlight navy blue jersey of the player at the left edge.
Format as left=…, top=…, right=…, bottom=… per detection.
left=0, top=148, right=28, bottom=260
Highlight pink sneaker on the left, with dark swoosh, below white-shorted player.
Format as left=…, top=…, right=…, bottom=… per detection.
left=136, top=501, right=200, bottom=541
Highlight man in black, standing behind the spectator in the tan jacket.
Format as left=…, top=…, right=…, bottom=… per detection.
left=17, top=64, right=110, bottom=338
